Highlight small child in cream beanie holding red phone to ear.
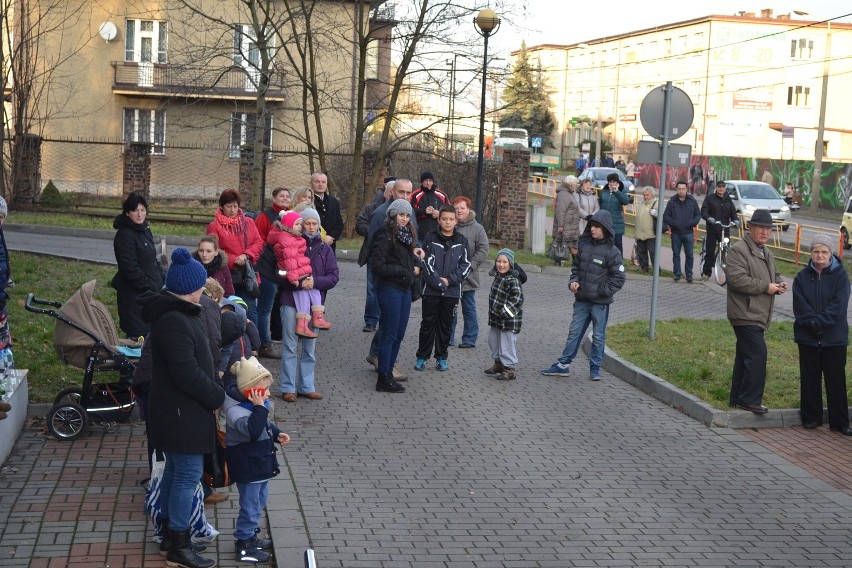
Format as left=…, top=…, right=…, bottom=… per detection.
left=223, top=357, right=290, bottom=564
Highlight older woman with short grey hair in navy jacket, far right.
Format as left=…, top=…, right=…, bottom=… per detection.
left=793, top=235, right=852, bottom=436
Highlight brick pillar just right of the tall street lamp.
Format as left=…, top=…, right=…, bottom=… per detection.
left=496, top=148, right=530, bottom=250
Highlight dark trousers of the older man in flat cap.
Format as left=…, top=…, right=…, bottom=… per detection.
left=730, top=325, right=767, bottom=406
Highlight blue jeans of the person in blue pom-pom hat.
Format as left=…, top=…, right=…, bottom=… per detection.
left=160, top=452, right=204, bottom=532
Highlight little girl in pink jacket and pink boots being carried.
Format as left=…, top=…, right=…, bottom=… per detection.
left=266, top=209, right=331, bottom=338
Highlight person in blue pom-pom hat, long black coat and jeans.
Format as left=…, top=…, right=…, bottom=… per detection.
left=139, top=248, right=225, bottom=567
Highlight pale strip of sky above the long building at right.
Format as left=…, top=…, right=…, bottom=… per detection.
left=489, top=0, right=852, bottom=53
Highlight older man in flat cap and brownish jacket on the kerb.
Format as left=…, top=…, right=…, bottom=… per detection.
left=725, top=209, right=787, bottom=414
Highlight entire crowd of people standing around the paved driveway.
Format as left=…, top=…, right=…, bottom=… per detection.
left=100, top=165, right=852, bottom=566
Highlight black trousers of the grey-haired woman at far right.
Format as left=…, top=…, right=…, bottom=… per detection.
left=799, top=344, right=849, bottom=430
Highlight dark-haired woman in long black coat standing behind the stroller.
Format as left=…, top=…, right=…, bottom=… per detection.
left=112, top=193, right=163, bottom=339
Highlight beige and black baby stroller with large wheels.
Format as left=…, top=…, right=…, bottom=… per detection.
left=24, top=280, right=141, bottom=440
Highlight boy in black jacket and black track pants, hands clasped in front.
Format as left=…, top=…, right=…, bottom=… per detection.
left=414, top=205, right=470, bottom=371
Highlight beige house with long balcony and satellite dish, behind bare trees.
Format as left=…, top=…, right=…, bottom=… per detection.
left=3, top=0, right=393, bottom=197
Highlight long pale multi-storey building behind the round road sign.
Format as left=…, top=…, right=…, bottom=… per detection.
left=529, top=10, right=852, bottom=162
